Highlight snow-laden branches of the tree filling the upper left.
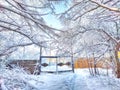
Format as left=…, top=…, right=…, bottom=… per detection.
left=0, top=0, right=60, bottom=56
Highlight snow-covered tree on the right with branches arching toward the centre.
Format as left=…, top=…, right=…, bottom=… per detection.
left=58, top=0, right=120, bottom=77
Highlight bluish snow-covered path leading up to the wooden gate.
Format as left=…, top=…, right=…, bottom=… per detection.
left=36, top=73, right=89, bottom=90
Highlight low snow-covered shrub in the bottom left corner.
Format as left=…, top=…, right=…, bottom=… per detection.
left=0, top=67, right=42, bottom=90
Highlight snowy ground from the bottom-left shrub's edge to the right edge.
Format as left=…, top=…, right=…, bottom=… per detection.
left=27, top=69, right=120, bottom=90
